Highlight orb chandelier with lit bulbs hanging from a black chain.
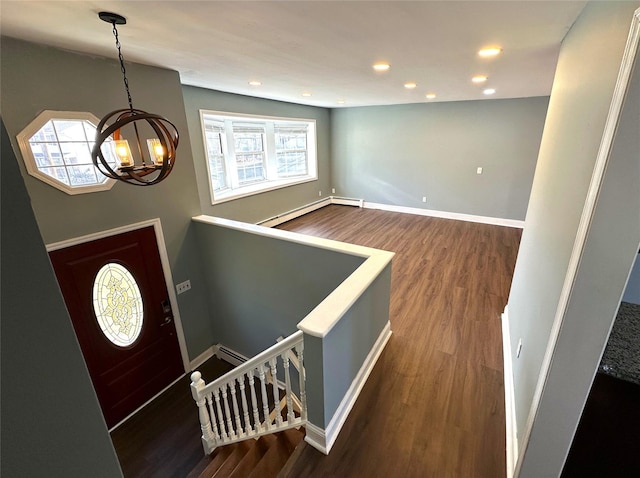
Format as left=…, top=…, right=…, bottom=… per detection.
left=91, top=12, right=179, bottom=186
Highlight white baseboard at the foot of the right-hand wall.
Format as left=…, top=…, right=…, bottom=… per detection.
left=502, top=305, right=518, bottom=478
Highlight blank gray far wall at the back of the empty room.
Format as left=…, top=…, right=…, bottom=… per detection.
left=331, top=97, right=548, bottom=220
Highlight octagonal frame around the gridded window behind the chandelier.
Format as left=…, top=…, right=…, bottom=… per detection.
left=17, top=110, right=116, bottom=195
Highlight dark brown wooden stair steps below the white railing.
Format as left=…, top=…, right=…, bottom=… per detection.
left=188, top=428, right=304, bottom=478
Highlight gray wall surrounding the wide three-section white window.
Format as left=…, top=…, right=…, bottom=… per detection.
left=182, top=86, right=331, bottom=223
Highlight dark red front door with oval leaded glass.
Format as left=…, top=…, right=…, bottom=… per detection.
left=50, top=226, right=184, bottom=428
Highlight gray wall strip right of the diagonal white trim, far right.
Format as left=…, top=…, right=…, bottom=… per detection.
left=521, top=40, right=640, bottom=477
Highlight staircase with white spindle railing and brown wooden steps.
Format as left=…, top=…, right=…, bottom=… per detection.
left=189, top=331, right=307, bottom=478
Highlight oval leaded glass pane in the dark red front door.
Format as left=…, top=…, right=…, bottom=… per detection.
left=93, top=262, right=144, bottom=347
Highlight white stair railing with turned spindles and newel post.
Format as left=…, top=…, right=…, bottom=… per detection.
left=191, top=331, right=307, bottom=454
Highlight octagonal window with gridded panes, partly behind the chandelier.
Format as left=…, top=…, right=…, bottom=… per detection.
left=17, top=110, right=116, bottom=195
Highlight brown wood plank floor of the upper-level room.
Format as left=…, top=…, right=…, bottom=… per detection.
left=279, top=206, right=521, bottom=478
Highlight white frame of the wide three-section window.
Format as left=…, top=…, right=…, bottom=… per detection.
left=200, top=110, right=318, bottom=205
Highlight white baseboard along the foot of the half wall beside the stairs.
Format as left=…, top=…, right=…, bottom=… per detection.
left=305, top=321, right=392, bottom=455
